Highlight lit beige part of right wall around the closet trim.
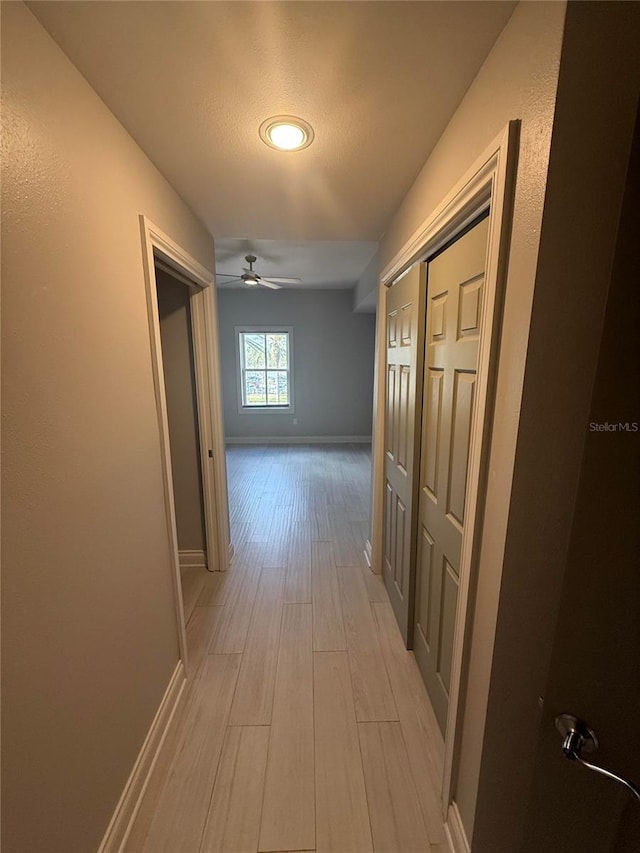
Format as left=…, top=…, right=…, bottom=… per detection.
left=381, top=3, right=565, bottom=838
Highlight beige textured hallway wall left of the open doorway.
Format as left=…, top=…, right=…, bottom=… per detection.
left=2, top=3, right=213, bottom=853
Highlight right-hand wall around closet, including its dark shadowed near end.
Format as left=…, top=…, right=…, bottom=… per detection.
left=381, top=2, right=640, bottom=853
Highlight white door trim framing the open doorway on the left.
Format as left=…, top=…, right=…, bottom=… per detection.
left=140, top=215, right=230, bottom=668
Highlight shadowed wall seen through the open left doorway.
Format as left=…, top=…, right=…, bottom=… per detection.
left=156, top=270, right=207, bottom=551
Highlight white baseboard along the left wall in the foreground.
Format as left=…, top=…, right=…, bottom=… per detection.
left=98, top=661, right=185, bottom=853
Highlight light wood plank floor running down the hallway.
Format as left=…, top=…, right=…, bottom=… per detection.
left=124, top=445, right=448, bottom=853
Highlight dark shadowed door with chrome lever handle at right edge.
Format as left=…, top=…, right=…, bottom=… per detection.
left=524, top=98, right=640, bottom=853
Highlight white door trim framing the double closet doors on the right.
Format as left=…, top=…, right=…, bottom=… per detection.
left=371, top=121, right=519, bottom=820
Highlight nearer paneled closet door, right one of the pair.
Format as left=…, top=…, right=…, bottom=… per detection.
left=414, top=218, right=489, bottom=734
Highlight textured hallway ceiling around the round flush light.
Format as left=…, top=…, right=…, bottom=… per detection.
left=28, top=0, right=515, bottom=286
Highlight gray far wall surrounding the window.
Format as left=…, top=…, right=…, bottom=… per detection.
left=218, top=289, right=375, bottom=438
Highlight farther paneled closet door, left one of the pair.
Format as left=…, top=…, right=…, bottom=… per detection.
left=382, top=264, right=425, bottom=648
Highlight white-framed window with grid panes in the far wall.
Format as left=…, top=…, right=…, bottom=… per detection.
left=236, top=326, right=293, bottom=412
